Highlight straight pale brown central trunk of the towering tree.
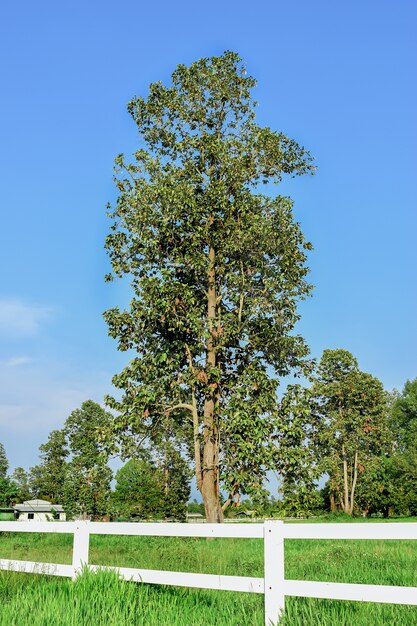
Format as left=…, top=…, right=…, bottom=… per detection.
left=201, top=246, right=223, bottom=523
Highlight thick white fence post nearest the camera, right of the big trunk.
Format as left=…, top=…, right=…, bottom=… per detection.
left=264, top=520, right=285, bottom=626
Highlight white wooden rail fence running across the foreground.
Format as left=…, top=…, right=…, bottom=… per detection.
left=0, top=520, right=417, bottom=626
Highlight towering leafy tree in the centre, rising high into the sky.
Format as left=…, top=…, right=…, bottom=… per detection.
left=105, top=52, right=314, bottom=522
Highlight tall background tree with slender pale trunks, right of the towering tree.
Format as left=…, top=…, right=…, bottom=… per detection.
left=312, top=349, right=390, bottom=515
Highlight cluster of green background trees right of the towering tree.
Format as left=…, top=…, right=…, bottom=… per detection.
left=228, top=349, right=417, bottom=517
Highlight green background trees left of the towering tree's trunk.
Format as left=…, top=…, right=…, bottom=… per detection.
left=0, top=400, right=190, bottom=520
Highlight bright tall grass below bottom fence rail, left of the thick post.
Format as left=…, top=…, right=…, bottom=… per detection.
left=0, top=571, right=263, bottom=626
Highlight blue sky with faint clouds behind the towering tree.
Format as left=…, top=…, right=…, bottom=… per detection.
left=0, top=0, right=417, bottom=478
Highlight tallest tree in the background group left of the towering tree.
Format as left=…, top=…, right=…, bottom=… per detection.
left=63, top=400, right=113, bottom=518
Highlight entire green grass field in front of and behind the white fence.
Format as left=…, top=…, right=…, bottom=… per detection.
left=0, top=519, right=417, bottom=626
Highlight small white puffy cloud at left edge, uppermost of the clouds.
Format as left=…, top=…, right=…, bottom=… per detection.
left=0, top=298, right=54, bottom=339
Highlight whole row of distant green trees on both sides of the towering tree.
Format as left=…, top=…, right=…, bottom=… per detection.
left=0, top=349, right=417, bottom=520
